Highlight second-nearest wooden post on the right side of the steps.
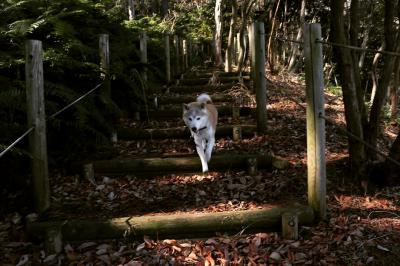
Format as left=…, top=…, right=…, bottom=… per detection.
left=251, top=21, right=267, bottom=133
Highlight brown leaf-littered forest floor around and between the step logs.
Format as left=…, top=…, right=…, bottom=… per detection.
left=0, top=69, right=400, bottom=266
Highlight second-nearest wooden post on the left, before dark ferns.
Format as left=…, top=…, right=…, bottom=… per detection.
left=99, top=34, right=111, bottom=96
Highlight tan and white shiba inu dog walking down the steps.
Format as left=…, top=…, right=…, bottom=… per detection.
left=183, top=93, right=218, bottom=173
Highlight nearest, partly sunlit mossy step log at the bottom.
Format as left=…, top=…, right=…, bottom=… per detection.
left=27, top=205, right=314, bottom=241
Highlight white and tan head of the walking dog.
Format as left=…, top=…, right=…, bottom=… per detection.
left=183, top=102, right=208, bottom=133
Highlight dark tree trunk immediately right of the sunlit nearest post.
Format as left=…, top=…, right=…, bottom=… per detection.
left=331, top=0, right=365, bottom=178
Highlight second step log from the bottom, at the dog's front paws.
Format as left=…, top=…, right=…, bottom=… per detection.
left=93, top=154, right=290, bottom=176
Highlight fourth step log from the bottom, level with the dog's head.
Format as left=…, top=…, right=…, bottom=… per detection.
left=140, top=105, right=256, bottom=119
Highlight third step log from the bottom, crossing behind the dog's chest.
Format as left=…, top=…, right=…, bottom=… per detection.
left=118, top=125, right=256, bottom=140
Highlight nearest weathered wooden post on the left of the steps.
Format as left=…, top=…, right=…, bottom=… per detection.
left=25, top=40, right=50, bottom=213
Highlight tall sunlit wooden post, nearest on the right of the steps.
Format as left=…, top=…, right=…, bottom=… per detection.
left=303, top=24, right=326, bottom=219
